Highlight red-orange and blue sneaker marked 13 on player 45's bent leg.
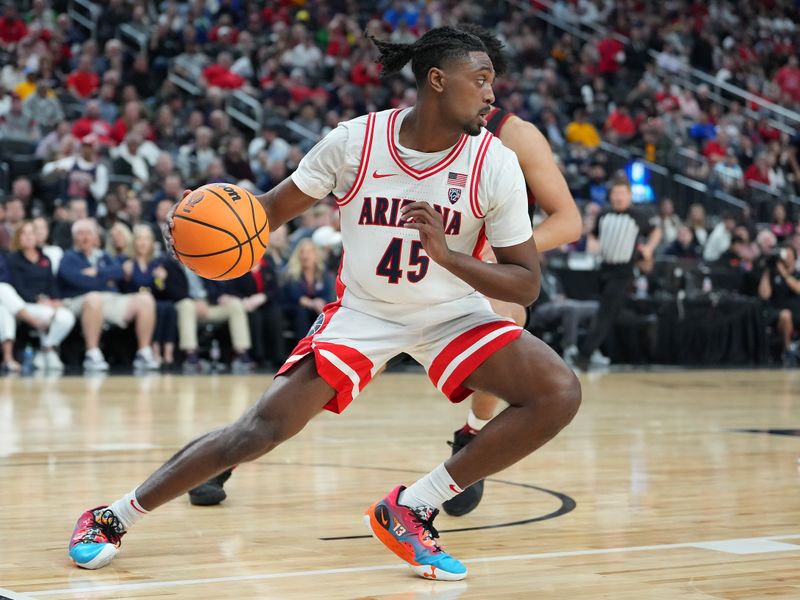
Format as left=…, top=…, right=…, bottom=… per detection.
left=364, top=485, right=467, bottom=581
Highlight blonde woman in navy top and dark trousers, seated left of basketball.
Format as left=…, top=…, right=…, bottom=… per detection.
left=123, top=224, right=178, bottom=370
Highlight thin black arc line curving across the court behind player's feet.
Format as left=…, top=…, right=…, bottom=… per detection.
left=4, top=460, right=578, bottom=542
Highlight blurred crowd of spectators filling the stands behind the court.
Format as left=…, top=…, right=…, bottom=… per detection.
left=0, top=0, right=800, bottom=372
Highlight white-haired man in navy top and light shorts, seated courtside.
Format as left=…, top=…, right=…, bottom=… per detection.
left=58, top=219, right=159, bottom=371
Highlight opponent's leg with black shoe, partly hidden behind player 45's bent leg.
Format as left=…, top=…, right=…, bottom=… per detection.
left=442, top=298, right=525, bottom=517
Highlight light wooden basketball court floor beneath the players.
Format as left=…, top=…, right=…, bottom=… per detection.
left=0, top=370, right=800, bottom=600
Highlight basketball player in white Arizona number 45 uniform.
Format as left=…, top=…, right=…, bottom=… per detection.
left=69, top=27, right=581, bottom=580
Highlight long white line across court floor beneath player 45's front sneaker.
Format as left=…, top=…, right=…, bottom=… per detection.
left=21, top=533, right=800, bottom=598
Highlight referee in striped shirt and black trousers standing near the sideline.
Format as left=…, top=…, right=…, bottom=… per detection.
left=575, top=175, right=661, bottom=371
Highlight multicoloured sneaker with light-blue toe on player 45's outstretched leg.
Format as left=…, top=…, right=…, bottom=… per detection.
left=69, top=506, right=125, bottom=569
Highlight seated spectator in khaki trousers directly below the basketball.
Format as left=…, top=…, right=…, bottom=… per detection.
left=175, top=267, right=251, bottom=373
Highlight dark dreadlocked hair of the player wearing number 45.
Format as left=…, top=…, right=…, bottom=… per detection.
left=367, top=25, right=488, bottom=86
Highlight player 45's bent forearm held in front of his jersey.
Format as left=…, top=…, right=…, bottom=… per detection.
left=440, top=252, right=540, bottom=306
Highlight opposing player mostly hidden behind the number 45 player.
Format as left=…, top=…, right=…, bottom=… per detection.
left=189, top=24, right=581, bottom=510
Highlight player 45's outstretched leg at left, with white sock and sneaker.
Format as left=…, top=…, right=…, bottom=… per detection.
left=69, top=356, right=334, bottom=569
